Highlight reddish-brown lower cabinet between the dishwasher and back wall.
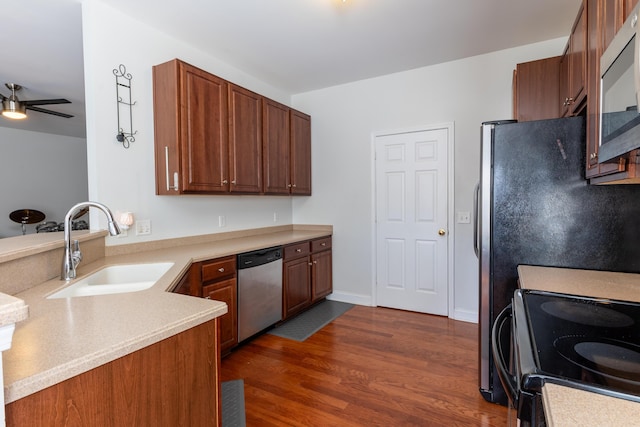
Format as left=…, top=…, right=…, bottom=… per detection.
left=282, top=237, right=333, bottom=319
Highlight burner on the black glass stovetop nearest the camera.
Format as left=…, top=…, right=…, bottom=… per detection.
left=553, top=335, right=640, bottom=390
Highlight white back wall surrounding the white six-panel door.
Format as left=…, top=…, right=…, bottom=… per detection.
left=293, top=38, right=566, bottom=321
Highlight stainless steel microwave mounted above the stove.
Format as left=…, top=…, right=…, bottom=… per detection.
left=598, top=7, right=640, bottom=162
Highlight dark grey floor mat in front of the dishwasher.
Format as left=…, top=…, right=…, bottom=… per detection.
left=269, top=300, right=353, bottom=341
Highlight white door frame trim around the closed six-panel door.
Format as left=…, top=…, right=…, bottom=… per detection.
left=370, top=122, right=455, bottom=318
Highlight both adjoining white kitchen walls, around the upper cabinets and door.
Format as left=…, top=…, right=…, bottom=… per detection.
left=83, top=0, right=566, bottom=321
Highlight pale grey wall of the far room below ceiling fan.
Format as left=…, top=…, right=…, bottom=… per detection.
left=0, top=129, right=87, bottom=237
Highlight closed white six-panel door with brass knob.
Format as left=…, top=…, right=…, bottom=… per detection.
left=375, top=127, right=449, bottom=315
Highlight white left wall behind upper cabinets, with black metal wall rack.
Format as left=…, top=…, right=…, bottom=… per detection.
left=82, top=0, right=292, bottom=245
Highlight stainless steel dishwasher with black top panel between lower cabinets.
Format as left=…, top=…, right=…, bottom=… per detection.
left=238, top=247, right=282, bottom=342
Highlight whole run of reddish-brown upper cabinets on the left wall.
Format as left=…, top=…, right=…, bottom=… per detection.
left=153, top=59, right=311, bottom=195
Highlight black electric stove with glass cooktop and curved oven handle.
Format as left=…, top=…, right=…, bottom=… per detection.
left=493, top=290, right=640, bottom=426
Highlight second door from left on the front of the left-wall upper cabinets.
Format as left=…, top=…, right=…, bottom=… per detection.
left=229, top=84, right=262, bottom=193
